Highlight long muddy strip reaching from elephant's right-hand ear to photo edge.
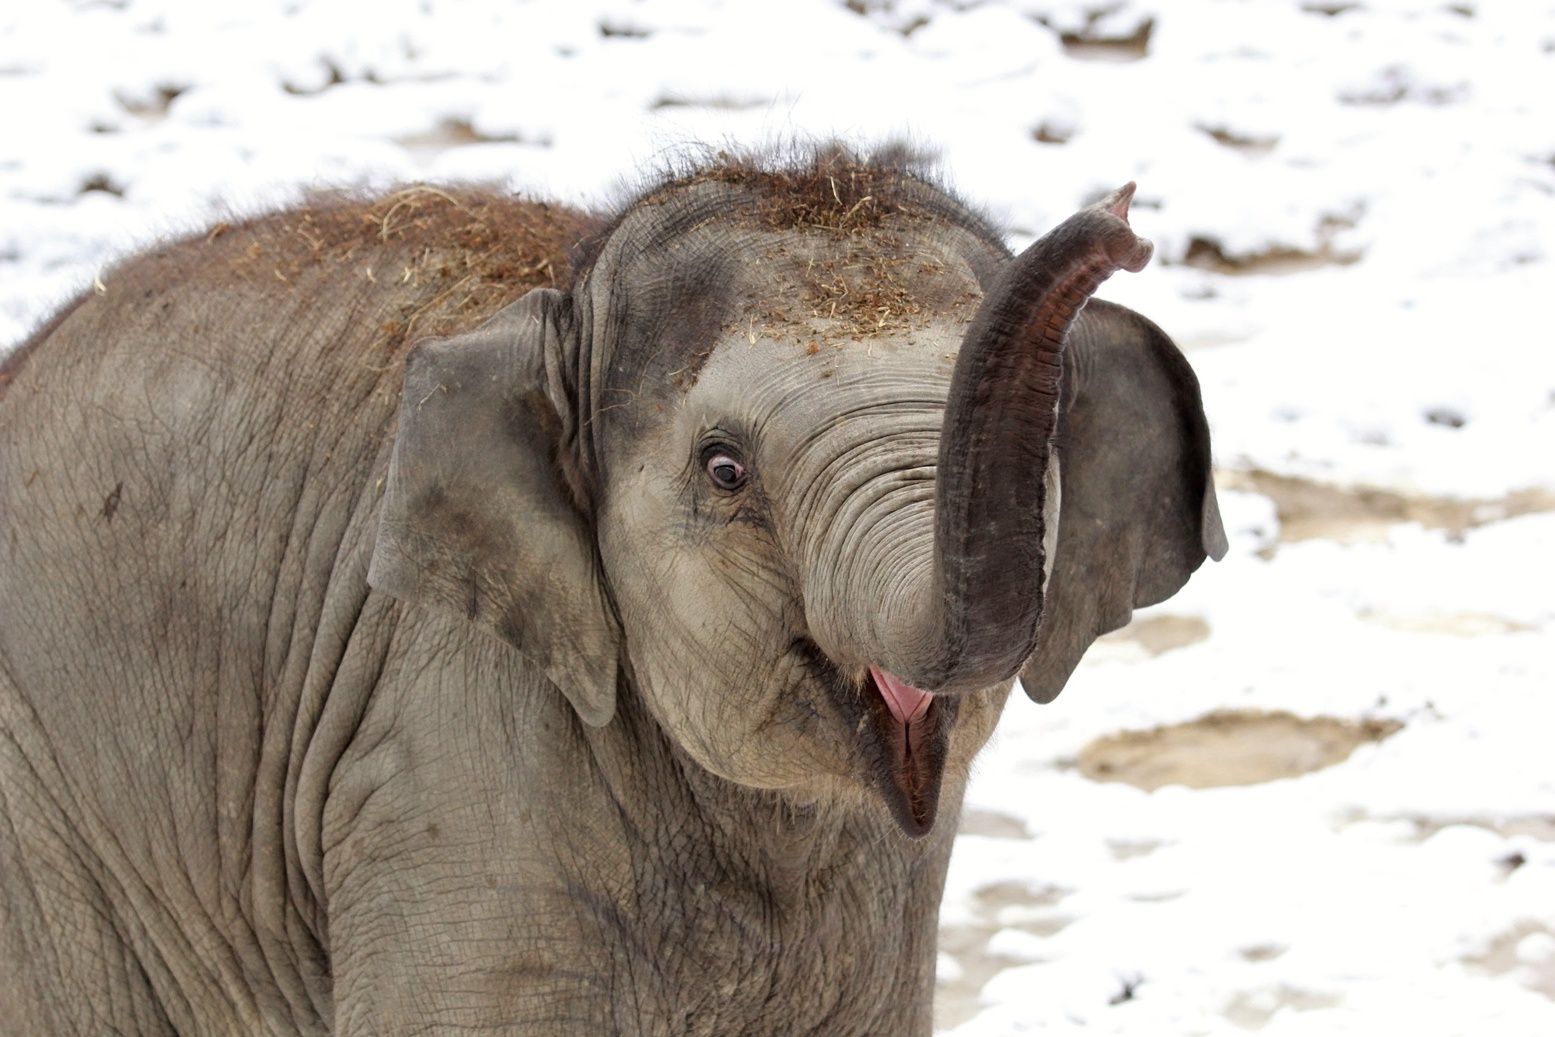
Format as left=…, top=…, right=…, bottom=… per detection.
left=1216, top=470, right=1555, bottom=543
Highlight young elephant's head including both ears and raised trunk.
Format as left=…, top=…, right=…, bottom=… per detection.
left=370, top=151, right=1224, bottom=835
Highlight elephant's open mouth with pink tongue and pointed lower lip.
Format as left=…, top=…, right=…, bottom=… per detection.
left=858, top=667, right=959, bottom=838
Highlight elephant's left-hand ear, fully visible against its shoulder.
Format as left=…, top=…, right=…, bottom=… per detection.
left=367, top=289, right=617, bottom=726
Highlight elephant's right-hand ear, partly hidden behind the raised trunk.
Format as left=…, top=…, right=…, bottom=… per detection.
left=1020, top=300, right=1227, bottom=703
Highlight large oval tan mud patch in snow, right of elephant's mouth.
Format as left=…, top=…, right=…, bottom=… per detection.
left=1079, top=711, right=1403, bottom=791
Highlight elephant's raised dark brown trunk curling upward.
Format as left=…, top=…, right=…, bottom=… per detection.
left=886, top=183, right=1152, bottom=690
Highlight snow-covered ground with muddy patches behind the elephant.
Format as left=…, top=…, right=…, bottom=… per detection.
left=0, top=0, right=1555, bottom=1037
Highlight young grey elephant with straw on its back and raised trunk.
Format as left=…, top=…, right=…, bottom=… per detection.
left=0, top=145, right=1225, bottom=1035
